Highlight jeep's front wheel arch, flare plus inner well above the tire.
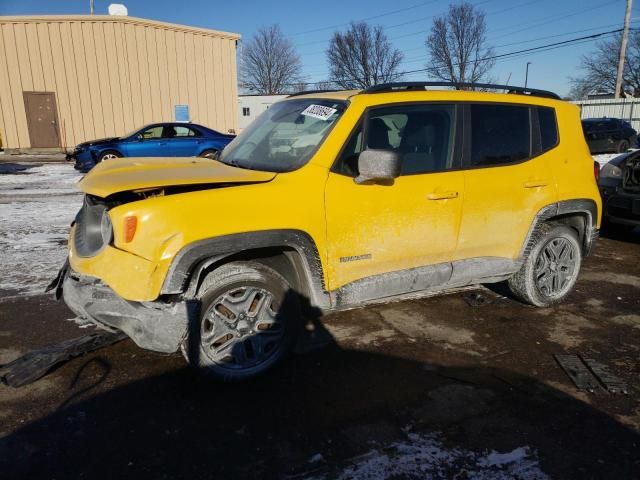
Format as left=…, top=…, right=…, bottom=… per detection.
left=161, top=230, right=330, bottom=308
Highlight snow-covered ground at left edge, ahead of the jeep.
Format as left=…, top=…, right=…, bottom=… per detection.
left=0, top=164, right=82, bottom=296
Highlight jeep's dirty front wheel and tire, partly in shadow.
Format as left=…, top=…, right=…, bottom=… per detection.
left=181, top=262, right=300, bottom=382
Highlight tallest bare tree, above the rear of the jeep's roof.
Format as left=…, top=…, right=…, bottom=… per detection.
left=425, top=3, right=495, bottom=83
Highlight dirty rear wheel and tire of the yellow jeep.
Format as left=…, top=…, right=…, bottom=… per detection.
left=508, top=223, right=582, bottom=307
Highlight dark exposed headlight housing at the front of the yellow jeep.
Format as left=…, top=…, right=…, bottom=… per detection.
left=73, top=196, right=113, bottom=257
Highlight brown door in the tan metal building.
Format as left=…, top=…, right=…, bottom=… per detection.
left=22, top=92, right=60, bottom=148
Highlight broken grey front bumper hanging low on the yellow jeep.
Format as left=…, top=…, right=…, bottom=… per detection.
left=56, top=266, right=190, bottom=353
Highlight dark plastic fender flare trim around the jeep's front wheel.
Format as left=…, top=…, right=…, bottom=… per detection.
left=160, top=229, right=330, bottom=308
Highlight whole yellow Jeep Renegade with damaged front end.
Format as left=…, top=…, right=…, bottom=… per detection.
left=56, top=83, right=601, bottom=380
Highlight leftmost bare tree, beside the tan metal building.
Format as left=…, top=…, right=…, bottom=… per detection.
left=240, top=25, right=302, bottom=95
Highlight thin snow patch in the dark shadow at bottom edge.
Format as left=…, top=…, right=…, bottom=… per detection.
left=310, top=433, right=549, bottom=480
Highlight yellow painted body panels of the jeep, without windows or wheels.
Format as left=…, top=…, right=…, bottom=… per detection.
left=70, top=91, right=601, bottom=300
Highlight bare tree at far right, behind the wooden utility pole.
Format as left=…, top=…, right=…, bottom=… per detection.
left=569, top=32, right=640, bottom=100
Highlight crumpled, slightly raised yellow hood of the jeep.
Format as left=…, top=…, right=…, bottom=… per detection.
left=79, top=157, right=276, bottom=198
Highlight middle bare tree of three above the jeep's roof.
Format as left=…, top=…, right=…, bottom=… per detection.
left=327, top=22, right=402, bottom=88
